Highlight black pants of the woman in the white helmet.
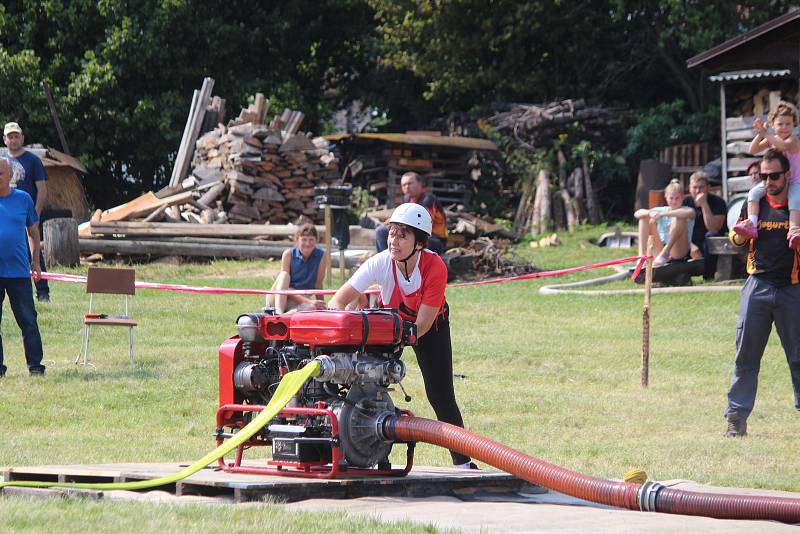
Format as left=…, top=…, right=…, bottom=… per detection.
left=414, top=303, right=470, bottom=465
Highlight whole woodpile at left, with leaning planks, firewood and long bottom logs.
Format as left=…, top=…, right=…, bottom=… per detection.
left=79, top=78, right=350, bottom=257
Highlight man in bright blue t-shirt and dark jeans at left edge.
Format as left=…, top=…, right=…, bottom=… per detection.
left=0, top=158, right=45, bottom=377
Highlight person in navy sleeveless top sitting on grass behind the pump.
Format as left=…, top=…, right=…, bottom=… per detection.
left=267, top=224, right=327, bottom=313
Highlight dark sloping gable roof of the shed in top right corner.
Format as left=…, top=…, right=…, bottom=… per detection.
left=686, top=8, right=800, bottom=70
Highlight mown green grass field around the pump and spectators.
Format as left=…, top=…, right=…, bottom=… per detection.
left=0, top=227, right=800, bottom=532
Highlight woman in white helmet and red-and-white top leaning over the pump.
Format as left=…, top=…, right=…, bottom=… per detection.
left=329, top=203, right=476, bottom=468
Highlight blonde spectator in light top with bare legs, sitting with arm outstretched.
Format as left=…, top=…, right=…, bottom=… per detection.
left=633, top=180, right=695, bottom=267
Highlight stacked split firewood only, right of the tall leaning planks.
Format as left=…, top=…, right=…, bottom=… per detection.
left=190, top=122, right=339, bottom=224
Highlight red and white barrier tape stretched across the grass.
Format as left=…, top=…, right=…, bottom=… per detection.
left=42, top=256, right=647, bottom=295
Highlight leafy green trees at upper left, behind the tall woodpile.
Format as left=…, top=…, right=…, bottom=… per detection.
left=0, top=0, right=373, bottom=207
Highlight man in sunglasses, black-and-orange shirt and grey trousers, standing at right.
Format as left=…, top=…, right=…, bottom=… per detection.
left=725, top=150, right=800, bottom=437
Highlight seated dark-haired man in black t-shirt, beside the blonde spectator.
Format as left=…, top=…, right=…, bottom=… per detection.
left=683, top=171, right=728, bottom=280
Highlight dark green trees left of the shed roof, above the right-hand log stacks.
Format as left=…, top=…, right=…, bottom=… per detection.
left=369, top=0, right=788, bottom=115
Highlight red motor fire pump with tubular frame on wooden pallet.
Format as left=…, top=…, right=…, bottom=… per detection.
left=216, top=309, right=416, bottom=478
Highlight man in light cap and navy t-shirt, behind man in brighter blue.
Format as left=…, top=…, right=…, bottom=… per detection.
left=3, top=122, right=50, bottom=302
